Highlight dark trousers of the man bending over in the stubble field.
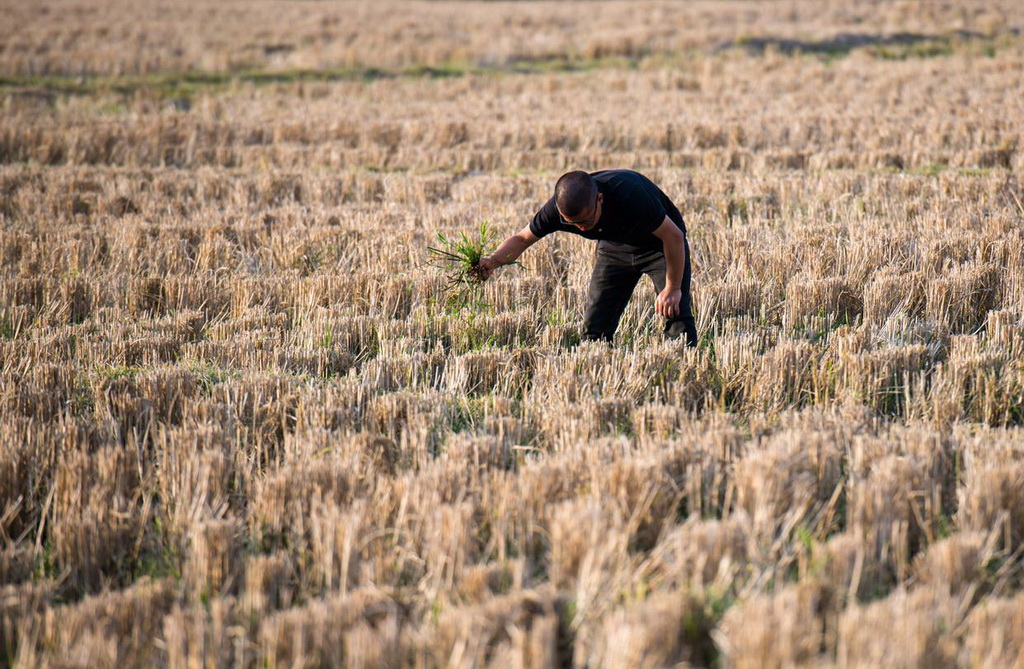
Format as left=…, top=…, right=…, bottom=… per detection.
left=583, top=238, right=697, bottom=346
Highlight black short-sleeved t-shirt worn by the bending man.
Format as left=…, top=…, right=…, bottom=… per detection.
left=529, top=170, right=686, bottom=250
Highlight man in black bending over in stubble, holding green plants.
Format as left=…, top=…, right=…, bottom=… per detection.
left=480, top=170, right=697, bottom=346
